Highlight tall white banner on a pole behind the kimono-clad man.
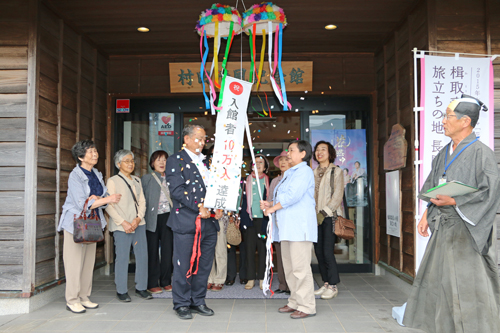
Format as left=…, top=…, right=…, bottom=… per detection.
left=420, top=55, right=494, bottom=187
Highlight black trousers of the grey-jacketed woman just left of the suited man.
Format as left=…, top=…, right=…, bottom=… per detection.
left=146, top=213, right=174, bottom=289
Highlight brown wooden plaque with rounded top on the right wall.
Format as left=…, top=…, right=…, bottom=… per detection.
left=384, top=124, right=408, bottom=170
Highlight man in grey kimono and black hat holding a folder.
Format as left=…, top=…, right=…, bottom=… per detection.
left=393, top=95, right=500, bottom=333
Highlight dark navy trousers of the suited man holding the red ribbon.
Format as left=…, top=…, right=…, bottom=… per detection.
left=172, top=221, right=217, bottom=309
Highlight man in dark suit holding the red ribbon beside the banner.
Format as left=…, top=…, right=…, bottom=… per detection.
left=165, top=124, right=222, bottom=319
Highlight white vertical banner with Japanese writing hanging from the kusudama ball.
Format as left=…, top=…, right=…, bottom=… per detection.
left=205, top=76, right=252, bottom=211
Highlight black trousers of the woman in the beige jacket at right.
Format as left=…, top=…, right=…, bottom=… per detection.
left=314, top=217, right=340, bottom=285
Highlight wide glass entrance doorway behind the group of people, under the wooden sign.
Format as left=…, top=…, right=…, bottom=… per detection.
left=115, top=97, right=373, bottom=272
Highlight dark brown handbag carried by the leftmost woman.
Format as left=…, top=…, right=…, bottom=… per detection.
left=73, top=199, right=104, bottom=244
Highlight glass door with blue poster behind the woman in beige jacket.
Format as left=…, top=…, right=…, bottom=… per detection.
left=303, top=111, right=372, bottom=272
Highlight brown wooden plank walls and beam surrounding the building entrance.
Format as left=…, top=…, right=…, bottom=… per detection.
left=0, top=0, right=500, bottom=310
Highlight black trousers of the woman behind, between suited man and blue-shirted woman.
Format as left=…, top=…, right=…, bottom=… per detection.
left=245, top=218, right=266, bottom=280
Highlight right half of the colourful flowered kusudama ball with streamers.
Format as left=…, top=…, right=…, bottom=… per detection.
left=243, top=2, right=287, bottom=35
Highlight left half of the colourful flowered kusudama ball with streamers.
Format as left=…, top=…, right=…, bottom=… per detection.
left=196, top=3, right=241, bottom=37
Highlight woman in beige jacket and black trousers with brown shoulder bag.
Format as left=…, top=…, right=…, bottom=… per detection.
left=313, top=141, right=344, bottom=299
